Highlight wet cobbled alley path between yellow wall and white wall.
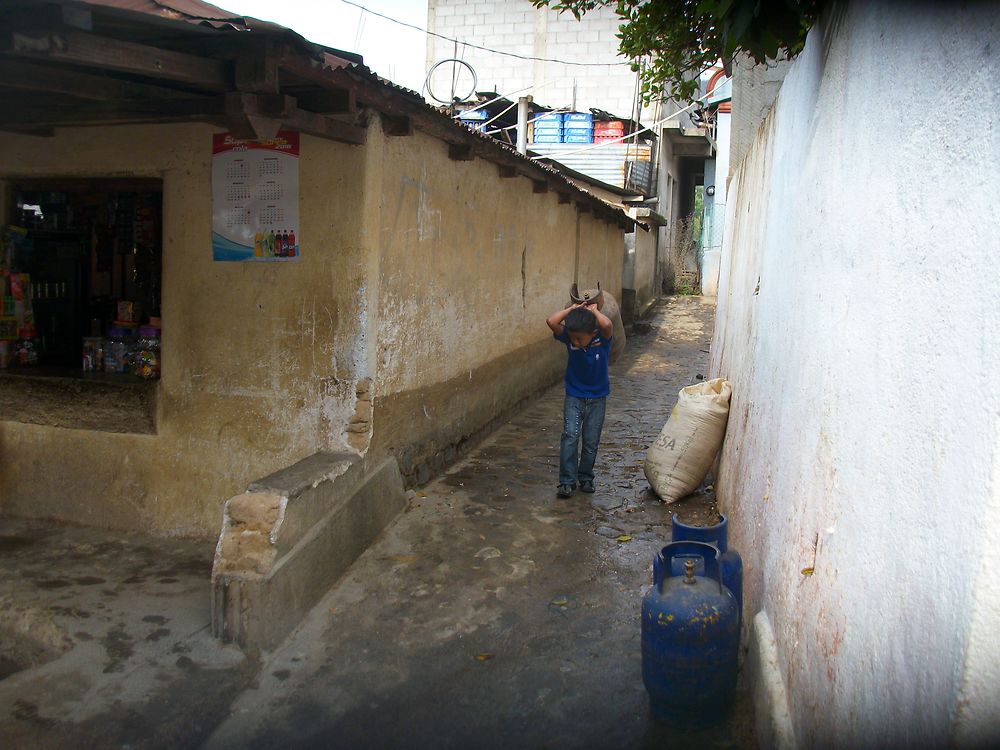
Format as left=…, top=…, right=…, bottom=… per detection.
left=208, top=297, right=754, bottom=750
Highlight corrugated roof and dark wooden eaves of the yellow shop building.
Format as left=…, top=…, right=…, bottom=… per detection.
left=0, top=0, right=633, bottom=226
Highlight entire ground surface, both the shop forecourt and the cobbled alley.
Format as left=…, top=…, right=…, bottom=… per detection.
left=0, top=297, right=755, bottom=750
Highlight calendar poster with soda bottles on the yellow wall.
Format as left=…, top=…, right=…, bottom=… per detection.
left=212, top=131, right=302, bottom=262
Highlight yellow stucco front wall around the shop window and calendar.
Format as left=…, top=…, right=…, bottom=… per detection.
left=0, top=125, right=367, bottom=536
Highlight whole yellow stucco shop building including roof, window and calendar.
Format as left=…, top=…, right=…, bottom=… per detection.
left=0, top=0, right=629, bottom=540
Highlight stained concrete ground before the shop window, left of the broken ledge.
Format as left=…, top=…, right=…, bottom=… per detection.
left=0, top=519, right=249, bottom=749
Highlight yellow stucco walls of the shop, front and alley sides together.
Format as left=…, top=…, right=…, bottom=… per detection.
left=0, top=117, right=622, bottom=536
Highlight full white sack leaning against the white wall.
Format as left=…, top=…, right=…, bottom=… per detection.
left=643, top=378, right=733, bottom=503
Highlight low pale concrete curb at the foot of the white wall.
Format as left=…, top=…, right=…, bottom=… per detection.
left=745, top=610, right=798, bottom=750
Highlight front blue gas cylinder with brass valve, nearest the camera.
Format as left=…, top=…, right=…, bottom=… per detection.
left=642, top=542, right=740, bottom=729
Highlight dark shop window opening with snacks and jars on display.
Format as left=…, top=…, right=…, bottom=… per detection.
left=0, top=179, right=162, bottom=382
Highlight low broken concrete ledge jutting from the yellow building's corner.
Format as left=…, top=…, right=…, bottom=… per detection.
left=212, top=453, right=406, bottom=651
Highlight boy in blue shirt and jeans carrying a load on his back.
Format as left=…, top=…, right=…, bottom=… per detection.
left=545, top=303, right=612, bottom=497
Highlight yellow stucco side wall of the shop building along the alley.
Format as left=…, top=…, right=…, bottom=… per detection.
left=369, top=126, right=623, bottom=481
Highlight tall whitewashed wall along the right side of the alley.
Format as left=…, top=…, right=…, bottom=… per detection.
left=712, top=1, right=1000, bottom=748
